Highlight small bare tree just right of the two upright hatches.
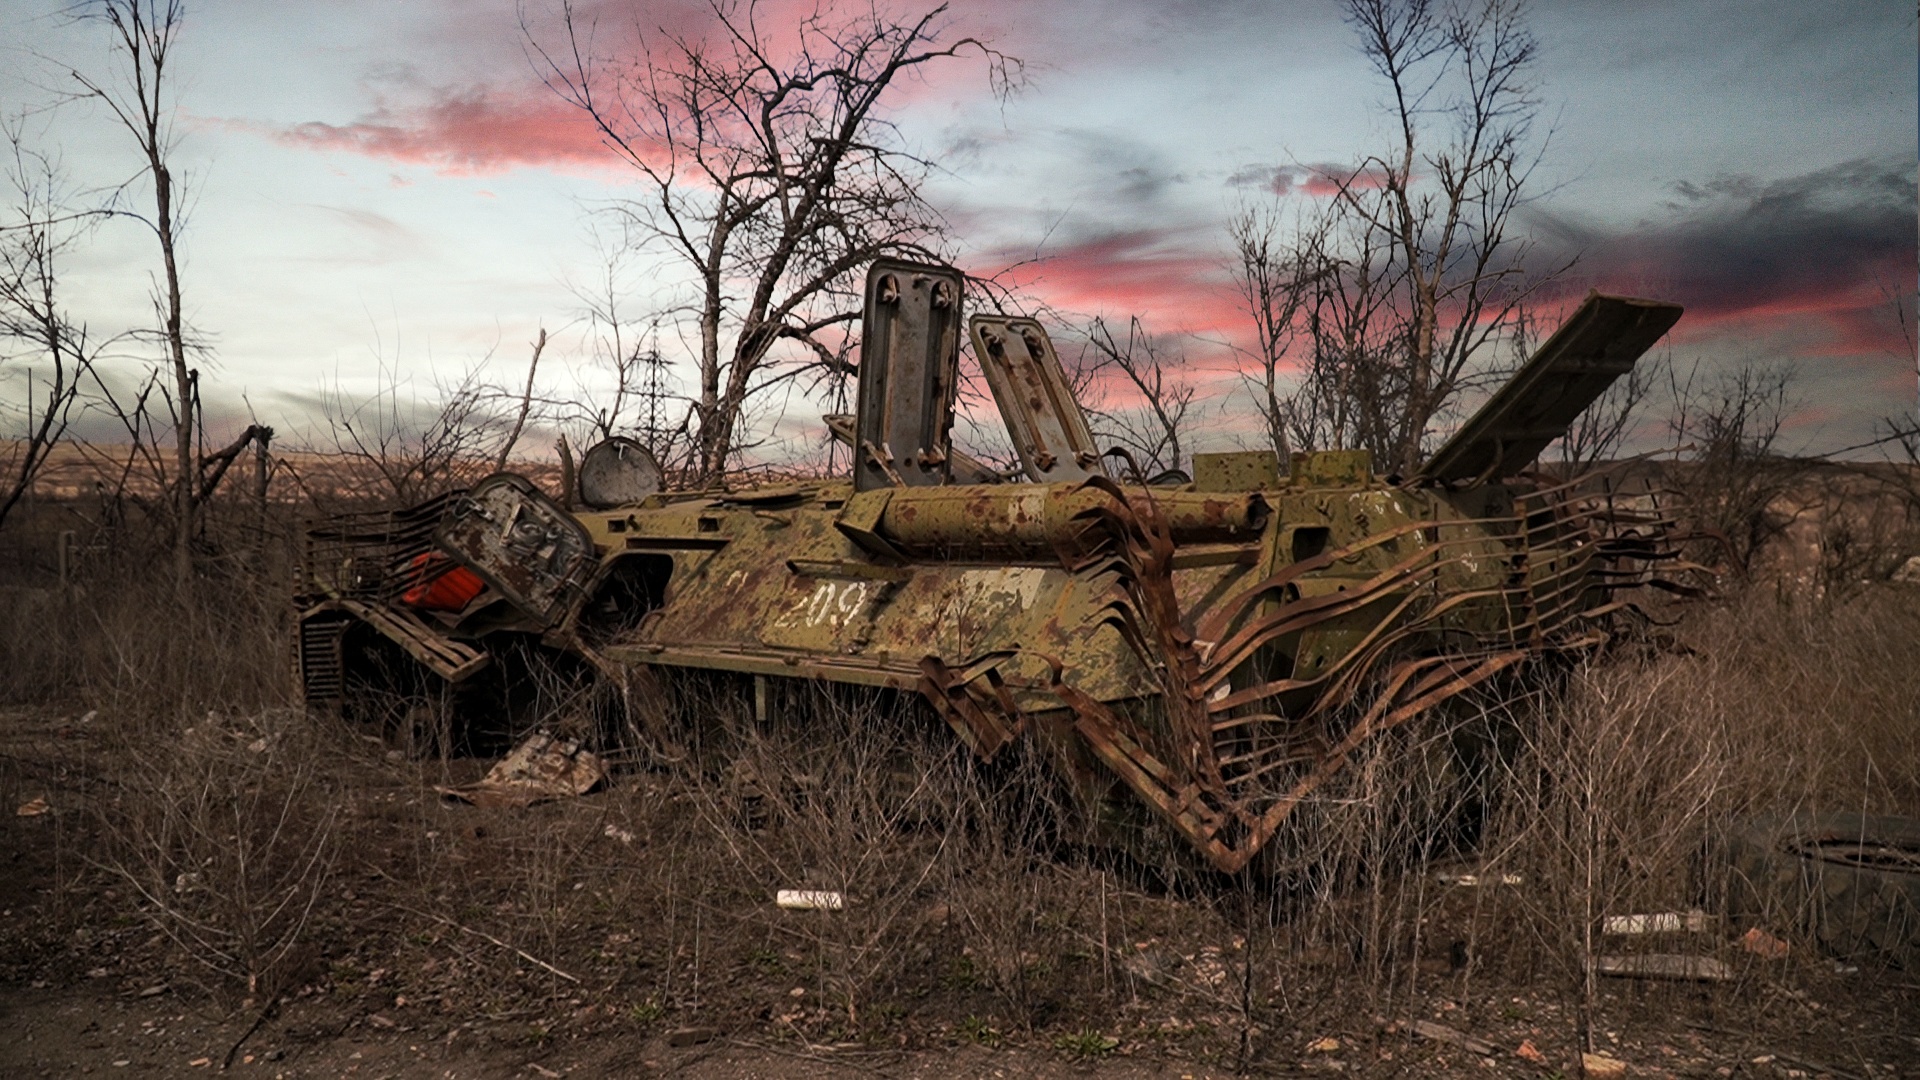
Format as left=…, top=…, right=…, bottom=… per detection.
left=1075, top=315, right=1194, bottom=479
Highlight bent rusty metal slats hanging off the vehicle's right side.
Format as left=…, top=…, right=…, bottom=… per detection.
left=1052, top=466, right=1678, bottom=872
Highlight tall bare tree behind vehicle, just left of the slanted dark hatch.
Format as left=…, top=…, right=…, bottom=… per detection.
left=1235, top=0, right=1565, bottom=473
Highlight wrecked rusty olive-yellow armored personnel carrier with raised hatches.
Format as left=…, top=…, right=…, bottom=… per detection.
left=296, top=261, right=1680, bottom=872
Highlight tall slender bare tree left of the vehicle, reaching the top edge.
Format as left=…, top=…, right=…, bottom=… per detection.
left=73, top=0, right=200, bottom=586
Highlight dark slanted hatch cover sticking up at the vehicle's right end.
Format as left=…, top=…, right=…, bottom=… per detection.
left=1417, top=292, right=1682, bottom=484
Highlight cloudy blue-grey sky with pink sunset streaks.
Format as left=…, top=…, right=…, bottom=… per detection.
left=0, top=0, right=1920, bottom=452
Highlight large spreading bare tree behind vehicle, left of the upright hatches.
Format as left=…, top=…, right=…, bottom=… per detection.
left=528, top=0, right=1020, bottom=482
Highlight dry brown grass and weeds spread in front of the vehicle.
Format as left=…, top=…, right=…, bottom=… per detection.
left=0, top=490, right=1920, bottom=1061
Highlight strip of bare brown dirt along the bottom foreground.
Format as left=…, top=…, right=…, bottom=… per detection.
left=0, top=980, right=1920, bottom=1080
